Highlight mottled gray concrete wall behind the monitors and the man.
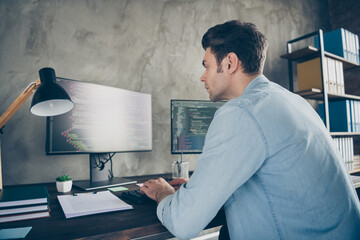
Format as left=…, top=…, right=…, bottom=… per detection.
left=0, top=0, right=329, bottom=185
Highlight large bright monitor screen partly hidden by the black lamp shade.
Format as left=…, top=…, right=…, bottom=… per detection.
left=46, top=78, right=152, bottom=154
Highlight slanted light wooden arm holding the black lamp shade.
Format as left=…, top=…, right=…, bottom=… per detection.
left=0, top=78, right=40, bottom=130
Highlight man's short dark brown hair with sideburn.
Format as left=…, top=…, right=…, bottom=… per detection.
left=201, top=20, right=267, bottom=75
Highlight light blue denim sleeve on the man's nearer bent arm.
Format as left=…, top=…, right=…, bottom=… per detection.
left=157, top=105, right=267, bottom=238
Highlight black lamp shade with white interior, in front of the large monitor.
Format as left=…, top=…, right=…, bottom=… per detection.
left=30, top=68, right=74, bottom=116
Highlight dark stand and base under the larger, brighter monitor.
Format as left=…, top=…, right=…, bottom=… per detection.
left=74, top=154, right=136, bottom=191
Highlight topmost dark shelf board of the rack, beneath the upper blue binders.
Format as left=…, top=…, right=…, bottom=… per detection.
left=281, top=46, right=360, bottom=71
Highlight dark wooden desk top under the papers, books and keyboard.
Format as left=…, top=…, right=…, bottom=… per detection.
left=0, top=175, right=225, bottom=240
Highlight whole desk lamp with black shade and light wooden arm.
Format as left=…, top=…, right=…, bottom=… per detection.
left=0, top=68, right=74, bottom=191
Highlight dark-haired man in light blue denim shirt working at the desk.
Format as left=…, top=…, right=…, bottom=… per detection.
left=141, top=21, right=360, bottom=239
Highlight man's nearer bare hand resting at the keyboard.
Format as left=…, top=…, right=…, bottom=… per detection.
left=140, top=178, right=175, bottom=204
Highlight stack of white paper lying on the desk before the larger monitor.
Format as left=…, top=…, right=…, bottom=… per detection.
left=57, top=191, right=133, bottom=218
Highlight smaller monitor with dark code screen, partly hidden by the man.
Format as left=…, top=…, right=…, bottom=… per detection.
left=170, top=100, right=225, bottom=154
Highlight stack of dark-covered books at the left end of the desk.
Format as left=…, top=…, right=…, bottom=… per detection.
left=0, top=185, right=50, bottom=223
